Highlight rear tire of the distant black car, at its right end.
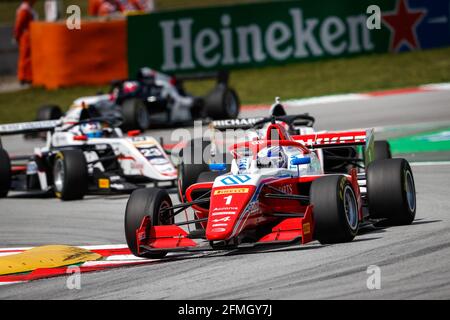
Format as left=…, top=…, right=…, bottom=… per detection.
left=204, top=84, right=240, bottom=119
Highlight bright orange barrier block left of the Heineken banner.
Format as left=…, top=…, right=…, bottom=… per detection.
left=31, top=20, right=128, bottom=89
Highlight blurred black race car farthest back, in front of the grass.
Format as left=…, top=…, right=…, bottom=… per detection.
left=36, top=68, right=240, bottom=130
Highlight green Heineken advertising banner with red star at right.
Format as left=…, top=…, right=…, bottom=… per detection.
left=128, top=0, right=450, bottom=76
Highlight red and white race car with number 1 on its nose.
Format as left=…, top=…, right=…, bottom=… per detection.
left=125, top=106, right=416, bottom=258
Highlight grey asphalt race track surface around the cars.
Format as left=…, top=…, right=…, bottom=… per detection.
left=0, top=91, right=450, bottom=299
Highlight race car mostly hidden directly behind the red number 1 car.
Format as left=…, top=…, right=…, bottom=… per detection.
left=172, top=98, right=392, bottom=201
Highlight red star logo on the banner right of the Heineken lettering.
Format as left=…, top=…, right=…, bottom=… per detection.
left=382, top=0, right=426, bottom=52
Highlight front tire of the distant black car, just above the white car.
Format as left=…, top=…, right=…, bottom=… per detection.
left=122, top=98, right=150, bottom=131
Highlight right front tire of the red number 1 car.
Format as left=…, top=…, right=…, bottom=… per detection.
left=310, top=175, right=359, bottom=244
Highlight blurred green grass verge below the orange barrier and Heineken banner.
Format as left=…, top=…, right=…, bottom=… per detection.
left=0, top=48, right=450, bottom=123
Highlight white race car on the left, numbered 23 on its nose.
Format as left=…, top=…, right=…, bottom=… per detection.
left=0, top=105, right=177, bottom=200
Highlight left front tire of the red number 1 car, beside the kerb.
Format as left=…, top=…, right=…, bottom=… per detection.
left=125, top=188, right=174, bottom=259
